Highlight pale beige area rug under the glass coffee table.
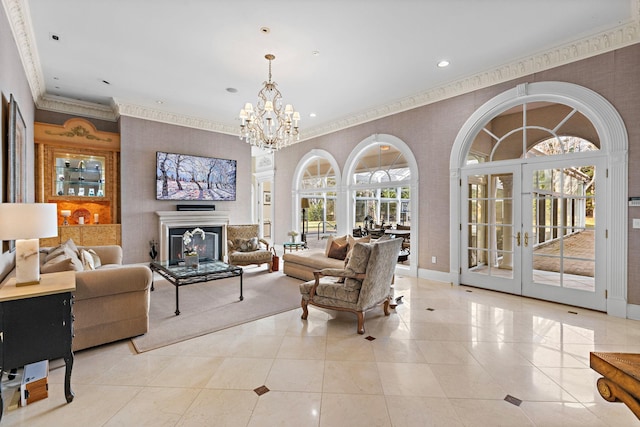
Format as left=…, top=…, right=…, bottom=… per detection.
left=131, top=266, right=302, bottom=353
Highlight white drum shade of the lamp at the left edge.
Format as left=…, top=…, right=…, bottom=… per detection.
left=0, top=203, right=58, bottom=240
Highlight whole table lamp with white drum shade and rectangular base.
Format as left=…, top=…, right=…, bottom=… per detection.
left=0, top=203, right=58, bottom=286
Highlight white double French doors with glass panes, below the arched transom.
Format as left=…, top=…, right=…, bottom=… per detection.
left=460, top=156, right=606, bottom=310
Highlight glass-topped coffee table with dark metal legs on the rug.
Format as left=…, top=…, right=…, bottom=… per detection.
left=149, top=260, right=244, bottom=316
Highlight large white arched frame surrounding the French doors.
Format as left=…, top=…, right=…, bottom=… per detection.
left=450, top=82, right=628, bottom=317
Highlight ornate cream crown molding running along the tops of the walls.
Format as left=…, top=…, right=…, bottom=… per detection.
left=2, top=0, right=640, bottom=142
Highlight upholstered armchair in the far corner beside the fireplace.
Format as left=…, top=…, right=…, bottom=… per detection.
left=227, top=224, right=273, bottom=273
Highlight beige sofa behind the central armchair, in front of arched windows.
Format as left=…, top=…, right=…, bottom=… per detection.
left=282, top=235, right=369, bottom=281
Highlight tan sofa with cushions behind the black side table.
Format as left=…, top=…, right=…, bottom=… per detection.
left=2, top=245, right=152, bottom=351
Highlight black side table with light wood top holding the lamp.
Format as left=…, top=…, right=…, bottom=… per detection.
left=0, top=271, right=76, bottom=420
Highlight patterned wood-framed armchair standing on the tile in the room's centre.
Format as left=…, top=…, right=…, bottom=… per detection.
left=300, top=239, right=402, bottom=334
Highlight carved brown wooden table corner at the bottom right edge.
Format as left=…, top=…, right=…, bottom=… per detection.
left=589, top=352, right=640, bottom=419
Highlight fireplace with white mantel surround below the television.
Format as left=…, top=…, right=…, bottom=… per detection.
left=156, top=211, right=229, bottom=261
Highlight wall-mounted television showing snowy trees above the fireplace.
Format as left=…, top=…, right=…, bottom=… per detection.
left=156, top=151, right=236, bottom=200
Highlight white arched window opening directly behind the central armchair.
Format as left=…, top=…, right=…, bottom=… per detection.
left=338, top=134, right=419, bottom=276
